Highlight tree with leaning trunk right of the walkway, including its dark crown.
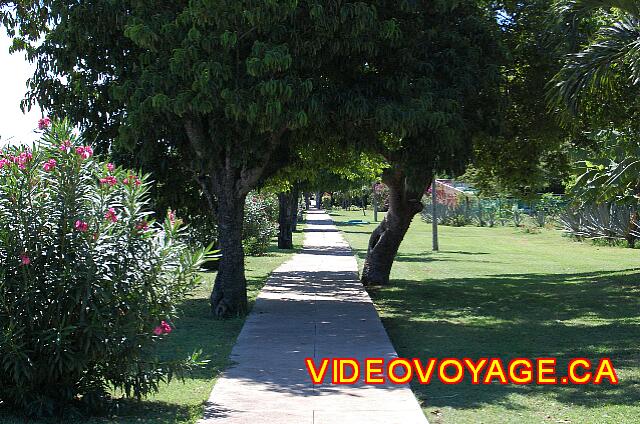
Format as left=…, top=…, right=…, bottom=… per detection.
left=350, top=1, right=501, bottom=285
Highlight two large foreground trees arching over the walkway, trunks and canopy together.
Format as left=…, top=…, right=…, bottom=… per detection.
left=0, top=0, right=503, bottom=316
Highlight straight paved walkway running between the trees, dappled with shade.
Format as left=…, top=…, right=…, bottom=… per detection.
left=200, top=210, right=427, bottom=424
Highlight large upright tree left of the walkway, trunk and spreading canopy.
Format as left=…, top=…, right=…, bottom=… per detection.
left=4, top=0, right=398, bottom=316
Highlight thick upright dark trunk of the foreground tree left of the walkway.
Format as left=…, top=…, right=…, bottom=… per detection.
left=211, top=188, right=248, bottom=317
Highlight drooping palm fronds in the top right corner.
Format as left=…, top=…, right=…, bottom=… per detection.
left=549, top=0, right=640, bottom=126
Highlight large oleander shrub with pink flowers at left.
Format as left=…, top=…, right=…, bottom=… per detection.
left=0, top=120, right=207, bottom=415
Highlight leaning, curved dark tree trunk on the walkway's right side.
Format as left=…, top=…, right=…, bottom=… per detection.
left=361, top=169, right=431, bottom=286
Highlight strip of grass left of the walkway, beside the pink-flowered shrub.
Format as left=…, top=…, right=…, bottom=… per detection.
left=0, top=227, right=303, bottom=424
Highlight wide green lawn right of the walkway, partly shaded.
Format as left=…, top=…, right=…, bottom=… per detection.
left=332, top=211, right=640, bottom=423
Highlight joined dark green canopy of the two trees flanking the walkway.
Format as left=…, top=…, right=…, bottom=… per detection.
left=5, top=0, right=500, bottom=190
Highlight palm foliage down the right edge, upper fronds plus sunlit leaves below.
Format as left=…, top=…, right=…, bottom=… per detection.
left=548, top=0, right=640, bottom=246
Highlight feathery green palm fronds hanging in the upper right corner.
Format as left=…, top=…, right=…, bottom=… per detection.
left=549, top=0, right=640, bottom=114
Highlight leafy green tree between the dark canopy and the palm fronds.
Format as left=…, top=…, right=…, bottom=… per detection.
left=467, top=0, right=577, bottom=197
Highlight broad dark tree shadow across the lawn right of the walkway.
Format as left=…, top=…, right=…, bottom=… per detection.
left=370, top=269, right=640, bottom=409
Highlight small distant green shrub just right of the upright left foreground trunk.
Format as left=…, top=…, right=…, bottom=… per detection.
left=243, top=193, right=278, bottom=256
